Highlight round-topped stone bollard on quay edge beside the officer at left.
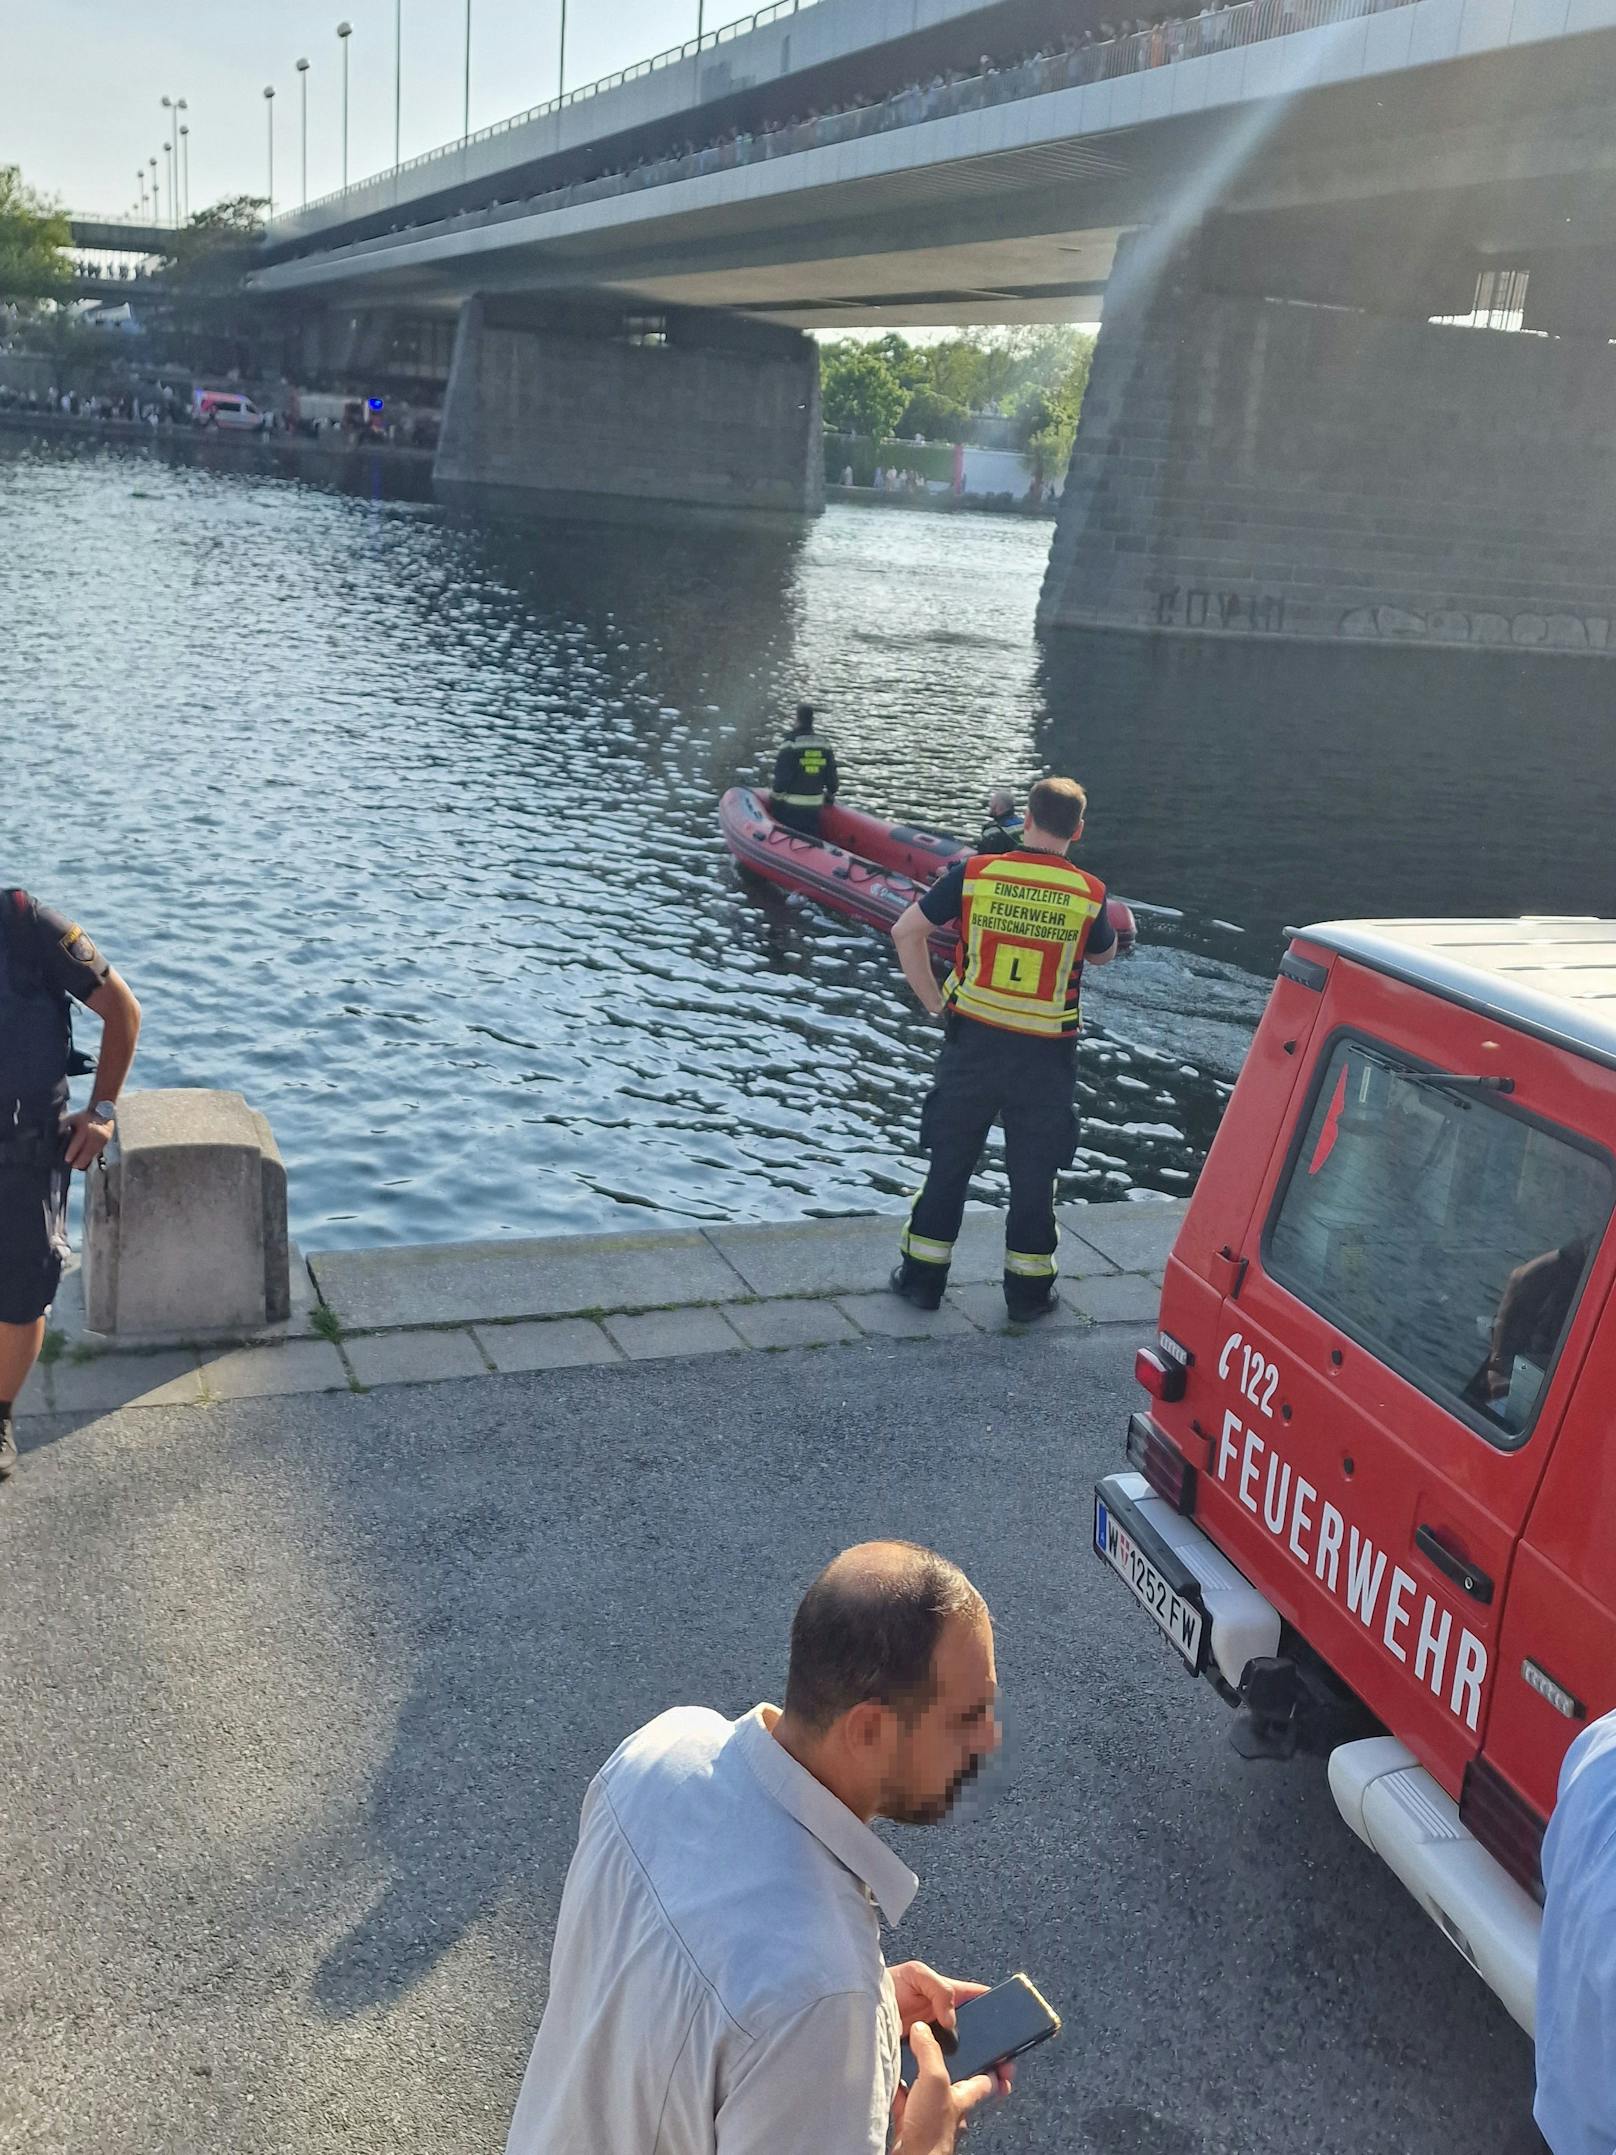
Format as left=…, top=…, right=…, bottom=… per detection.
left=84, top=1086, right=291, bottom=1338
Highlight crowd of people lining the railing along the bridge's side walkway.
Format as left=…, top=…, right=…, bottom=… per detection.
left=364, top=0, right=1407, bottom=244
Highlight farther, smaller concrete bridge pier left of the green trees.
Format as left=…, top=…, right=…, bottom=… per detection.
left=435, top=295, right=825, bottom=517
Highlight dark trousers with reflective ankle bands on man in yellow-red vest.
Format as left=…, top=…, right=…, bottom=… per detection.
left=903, top=1015, right=1077, bottom=1315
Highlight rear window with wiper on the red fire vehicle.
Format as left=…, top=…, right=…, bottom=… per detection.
left=1265, top=1039, right=1612, bottom=1440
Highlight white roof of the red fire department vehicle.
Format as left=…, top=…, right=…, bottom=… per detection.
left=1295, top=916, right=1616, bottom=1069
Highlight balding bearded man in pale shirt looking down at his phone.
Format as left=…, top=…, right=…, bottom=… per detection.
left=506, top=1541, right=1011, bottom=2155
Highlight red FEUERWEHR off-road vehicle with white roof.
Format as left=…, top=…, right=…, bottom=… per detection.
left=1095, top=920, right=1616, bottom=2032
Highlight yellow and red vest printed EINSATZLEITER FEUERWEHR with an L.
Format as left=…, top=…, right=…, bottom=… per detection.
left=944, top=851, right=1105, bottom=1041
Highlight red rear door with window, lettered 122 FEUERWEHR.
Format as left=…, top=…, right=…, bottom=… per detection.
left=1200, top=957, right=1616, bottom=1795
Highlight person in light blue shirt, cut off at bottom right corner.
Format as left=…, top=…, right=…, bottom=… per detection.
left=1534, top=1713, right=1616, bottom=2155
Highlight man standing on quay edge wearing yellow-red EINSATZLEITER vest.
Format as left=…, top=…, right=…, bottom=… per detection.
left=892, top=778, right=1116, bottom=1319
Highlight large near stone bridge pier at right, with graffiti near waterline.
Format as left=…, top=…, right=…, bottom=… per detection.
left=1039, top=216, right=1616, bottom=653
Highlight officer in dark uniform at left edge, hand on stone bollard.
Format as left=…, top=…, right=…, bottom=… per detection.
left=0, top=890, right=140, bottom=1480
